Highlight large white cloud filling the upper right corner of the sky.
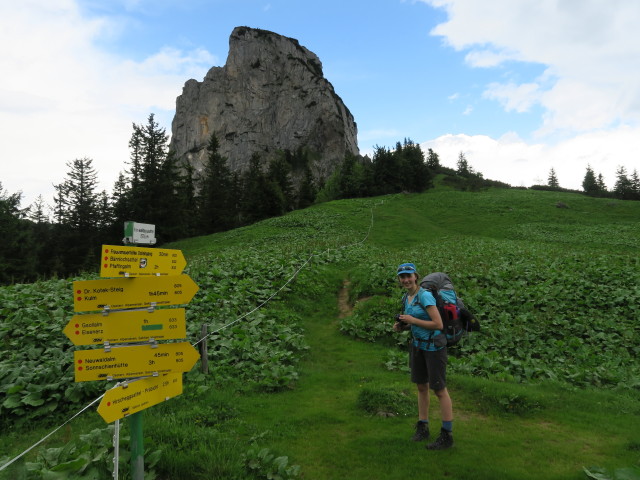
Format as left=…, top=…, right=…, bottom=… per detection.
left=423, top=0, right=640, bottom=134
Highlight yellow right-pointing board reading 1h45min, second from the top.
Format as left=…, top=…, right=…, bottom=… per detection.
left=73, top=274, right=198, bottom=312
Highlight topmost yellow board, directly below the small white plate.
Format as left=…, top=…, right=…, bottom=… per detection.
left=100, top=245, right=187, bottom=277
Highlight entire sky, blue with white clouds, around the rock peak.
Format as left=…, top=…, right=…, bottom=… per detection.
left=0, top=0, right=640, bottom=206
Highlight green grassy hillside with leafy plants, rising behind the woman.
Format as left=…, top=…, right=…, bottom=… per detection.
left=0, top=188, right=640, bottom=479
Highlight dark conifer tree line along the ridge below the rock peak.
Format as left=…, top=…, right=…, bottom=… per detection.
left=0, top=114, right=640, bottom=285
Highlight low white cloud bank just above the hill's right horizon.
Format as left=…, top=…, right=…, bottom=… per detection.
left=420, top=127, right=640, bottom=190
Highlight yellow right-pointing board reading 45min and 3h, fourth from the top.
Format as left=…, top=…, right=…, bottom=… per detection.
left=73, top=342, right=200, bottom=382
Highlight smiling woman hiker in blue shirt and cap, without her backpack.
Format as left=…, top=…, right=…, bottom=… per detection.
left=393, top=263, right=453, bottom=450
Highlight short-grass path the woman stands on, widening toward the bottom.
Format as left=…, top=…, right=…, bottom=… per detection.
left=229, top=271, right=639, bottom=480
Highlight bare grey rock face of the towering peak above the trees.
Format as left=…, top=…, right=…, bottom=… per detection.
left=171, top=27, right=359, bottom=178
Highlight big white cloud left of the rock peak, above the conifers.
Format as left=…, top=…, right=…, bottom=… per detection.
left=0, top=0, right=215, bottom=206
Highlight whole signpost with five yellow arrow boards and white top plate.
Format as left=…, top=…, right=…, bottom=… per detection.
left=63, top=228, right=200, bottom=480
